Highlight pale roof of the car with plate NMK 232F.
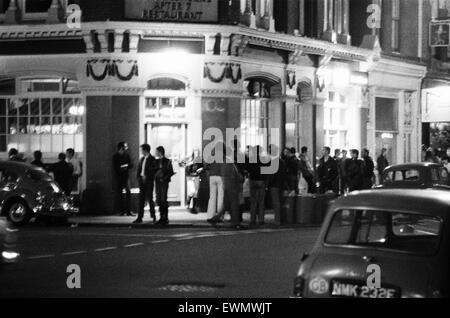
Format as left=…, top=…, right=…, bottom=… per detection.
left=332, top=189, right=450, bottom=218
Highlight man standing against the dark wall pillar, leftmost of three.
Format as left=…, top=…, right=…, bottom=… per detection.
left=113, top=142, right=133, bottom=216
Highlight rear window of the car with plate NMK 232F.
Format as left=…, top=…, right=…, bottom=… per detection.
left=325, top=210, right=442, bottom=254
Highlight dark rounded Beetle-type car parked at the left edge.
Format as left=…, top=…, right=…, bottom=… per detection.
left=0, top=161, right=78, bottom=225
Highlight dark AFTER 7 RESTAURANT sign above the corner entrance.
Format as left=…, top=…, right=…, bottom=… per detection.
left=125, top=0, right=219, bottom=22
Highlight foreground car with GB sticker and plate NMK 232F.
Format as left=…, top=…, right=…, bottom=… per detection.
left=294, top=189, right=450, bottom=298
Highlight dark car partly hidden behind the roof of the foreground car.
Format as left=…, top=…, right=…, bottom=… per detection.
left=379, top=163, right=450, bottom=190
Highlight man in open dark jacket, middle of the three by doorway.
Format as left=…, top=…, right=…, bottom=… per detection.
left=133, top=144, right=156, bottom=224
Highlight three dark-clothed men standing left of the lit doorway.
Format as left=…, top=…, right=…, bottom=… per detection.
left=113, top=142, right=175, bottom=226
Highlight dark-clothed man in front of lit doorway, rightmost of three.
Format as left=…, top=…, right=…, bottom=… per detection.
left=155, top=147, right=175, bottom=226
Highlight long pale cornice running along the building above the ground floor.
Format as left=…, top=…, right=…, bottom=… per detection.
left=0, top=21, right=379, bottom=61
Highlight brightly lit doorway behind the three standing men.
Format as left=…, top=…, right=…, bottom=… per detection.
left=145, top=123, right=187, bottom=206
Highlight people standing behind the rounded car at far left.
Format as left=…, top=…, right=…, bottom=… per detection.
left=8, top=148, right=83, bottom=196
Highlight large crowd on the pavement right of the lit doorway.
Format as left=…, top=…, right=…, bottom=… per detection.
left=180, top=141, right=389, bottom=227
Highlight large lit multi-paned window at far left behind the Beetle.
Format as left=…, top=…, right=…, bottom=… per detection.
left=0, top=97, right=85, bottom=153
